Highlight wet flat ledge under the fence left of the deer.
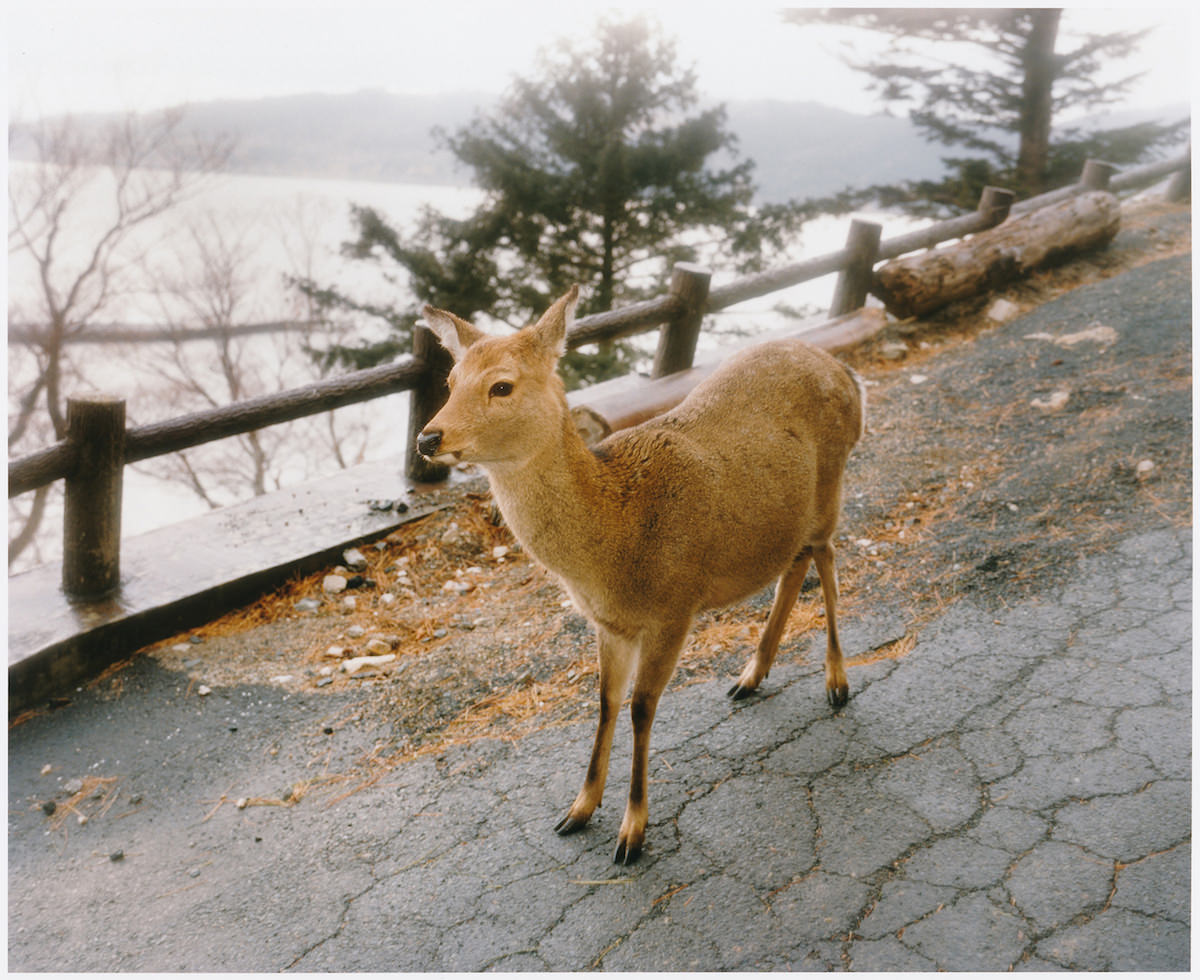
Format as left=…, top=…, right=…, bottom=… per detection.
left=8, top=459, right=464, bottom=715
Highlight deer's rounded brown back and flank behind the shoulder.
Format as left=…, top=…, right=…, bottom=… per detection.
left=583, top=341, right=862, bottom=607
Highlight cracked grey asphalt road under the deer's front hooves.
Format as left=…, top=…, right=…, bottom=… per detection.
left=8, top=247, right=1192, bottom=972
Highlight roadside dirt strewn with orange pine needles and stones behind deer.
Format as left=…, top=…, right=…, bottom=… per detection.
left=136, top=196, right=1192, bottom=780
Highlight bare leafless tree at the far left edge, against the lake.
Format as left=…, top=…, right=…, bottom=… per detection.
left=8, top=110, right=230, bottom=565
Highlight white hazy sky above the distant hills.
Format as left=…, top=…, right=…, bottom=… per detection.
left=5, top=0, right=1194, bottom=118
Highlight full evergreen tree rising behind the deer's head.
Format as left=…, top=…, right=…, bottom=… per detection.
left=300, top=18, right=800, bottom=383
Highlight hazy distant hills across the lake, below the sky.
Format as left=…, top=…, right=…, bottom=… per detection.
left=8, top=91, right=1188, bottom=200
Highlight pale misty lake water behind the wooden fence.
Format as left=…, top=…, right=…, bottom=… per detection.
left=8, top=163, right=912, bottom=570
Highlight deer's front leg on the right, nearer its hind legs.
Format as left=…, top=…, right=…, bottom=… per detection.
left=612, top=620, right=691, bottom=865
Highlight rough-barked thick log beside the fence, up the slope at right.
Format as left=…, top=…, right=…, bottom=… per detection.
left=871, top=191, right=1121, bottom=318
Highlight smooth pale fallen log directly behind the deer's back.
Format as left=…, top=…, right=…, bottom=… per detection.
left=568, top=306, right=887, bottom=436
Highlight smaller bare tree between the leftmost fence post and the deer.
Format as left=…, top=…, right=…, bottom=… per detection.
left=127, top=204, right=370, bottom=507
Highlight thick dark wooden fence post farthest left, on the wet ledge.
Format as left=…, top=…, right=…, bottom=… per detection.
left=62, top=395, right=125, bottom=600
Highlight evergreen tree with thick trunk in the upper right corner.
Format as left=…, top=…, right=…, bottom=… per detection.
left=784, top=7, right=1187, bottom=212
